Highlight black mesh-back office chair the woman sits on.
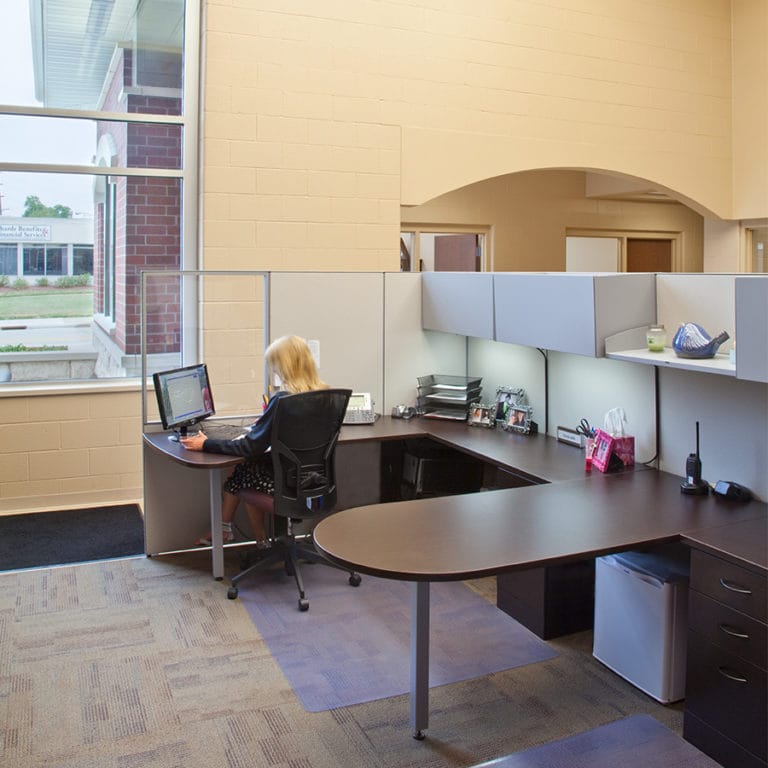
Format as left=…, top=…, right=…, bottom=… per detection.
left=227, top=389, right=360, bottom=611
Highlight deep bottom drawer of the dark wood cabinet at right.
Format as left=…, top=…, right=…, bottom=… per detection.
left=685, top=630, right=768, bottom=760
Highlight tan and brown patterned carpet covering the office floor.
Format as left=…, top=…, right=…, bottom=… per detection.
left=0, top=551, right=683, bottom=768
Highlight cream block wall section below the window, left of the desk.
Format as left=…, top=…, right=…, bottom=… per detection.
left=0, top=387, right=143, bottom=514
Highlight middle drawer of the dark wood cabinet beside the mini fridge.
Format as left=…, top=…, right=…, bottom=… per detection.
left=688, top=590, right=768, bottom=670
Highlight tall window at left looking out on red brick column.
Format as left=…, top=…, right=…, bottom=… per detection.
left=0, top=0, right=200, bottom=384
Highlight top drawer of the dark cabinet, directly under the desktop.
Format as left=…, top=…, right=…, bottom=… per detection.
left=690, top=549, right=768, bottom=622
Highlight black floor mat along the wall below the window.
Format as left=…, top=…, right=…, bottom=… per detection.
left=0, top=504, right=144, bottom=571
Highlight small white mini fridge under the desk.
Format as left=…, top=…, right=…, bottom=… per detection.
left=592, top=551, right=688, bottom=704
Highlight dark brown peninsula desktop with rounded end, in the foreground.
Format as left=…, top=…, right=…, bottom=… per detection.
left=314, top=470, right=766, bottom=581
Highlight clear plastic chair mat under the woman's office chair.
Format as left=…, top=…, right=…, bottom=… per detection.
left=238, top=565, right=557, bottom=712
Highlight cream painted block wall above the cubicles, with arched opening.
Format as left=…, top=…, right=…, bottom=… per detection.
left=203, top=0, right=766, bottom=270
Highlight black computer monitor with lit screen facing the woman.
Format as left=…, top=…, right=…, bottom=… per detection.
left=152, top=363, right=216, bottom=440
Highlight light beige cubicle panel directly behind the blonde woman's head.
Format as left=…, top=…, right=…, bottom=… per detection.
left=269, top=272, right=384, bottom=412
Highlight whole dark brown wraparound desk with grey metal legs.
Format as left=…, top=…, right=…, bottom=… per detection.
left=144, top=417, right=768, bottom=752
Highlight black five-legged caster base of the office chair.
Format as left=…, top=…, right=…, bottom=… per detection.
left=227, top=490, right=361, bottom=611
